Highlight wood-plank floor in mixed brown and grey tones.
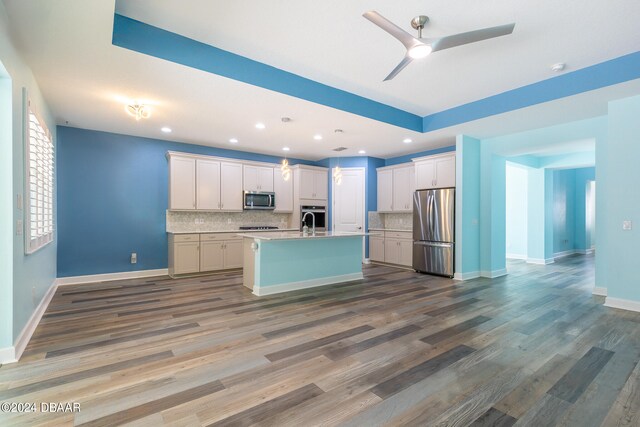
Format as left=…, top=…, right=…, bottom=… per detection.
left=0, top=256, right=640, bottom=427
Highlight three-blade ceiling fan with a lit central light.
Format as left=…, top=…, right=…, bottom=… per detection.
left=362, top=10, right=516, bottom=82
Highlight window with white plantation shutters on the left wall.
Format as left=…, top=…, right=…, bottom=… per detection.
left=25, top=101, right=53, bottom=253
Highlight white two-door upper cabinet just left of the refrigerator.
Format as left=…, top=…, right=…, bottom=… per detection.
left=378, top=164, right=415, bottom=212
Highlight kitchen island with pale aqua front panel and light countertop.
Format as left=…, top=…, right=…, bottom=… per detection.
left=239, top=231, right=367, bottom=296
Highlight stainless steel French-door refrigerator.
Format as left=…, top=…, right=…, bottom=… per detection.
left=413, top=188, right=455, bottom=277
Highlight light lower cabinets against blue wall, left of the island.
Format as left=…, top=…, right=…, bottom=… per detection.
left=169, top=233, right=242, bottom=276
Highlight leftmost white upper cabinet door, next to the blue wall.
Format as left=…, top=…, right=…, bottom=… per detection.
left=169, top=156, right=196, bottom=209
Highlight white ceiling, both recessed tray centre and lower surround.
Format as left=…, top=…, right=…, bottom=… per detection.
left=4, top=0, right=640, bottom=159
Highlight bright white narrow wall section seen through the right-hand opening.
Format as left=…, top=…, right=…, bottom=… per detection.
left=505, top=162, right=528, bottom=259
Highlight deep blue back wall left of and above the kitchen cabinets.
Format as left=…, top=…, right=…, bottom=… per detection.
left=56, top=126, right=313, bottom=277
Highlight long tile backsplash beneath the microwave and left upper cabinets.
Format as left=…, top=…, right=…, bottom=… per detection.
left=167, top=211, right=291, bottom=233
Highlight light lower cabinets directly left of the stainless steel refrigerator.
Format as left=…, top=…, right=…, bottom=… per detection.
left=369, top=231, right=413, bottom=267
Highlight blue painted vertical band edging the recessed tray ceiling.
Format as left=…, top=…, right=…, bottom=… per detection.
left=112, top=14, right=640, bottom=133
